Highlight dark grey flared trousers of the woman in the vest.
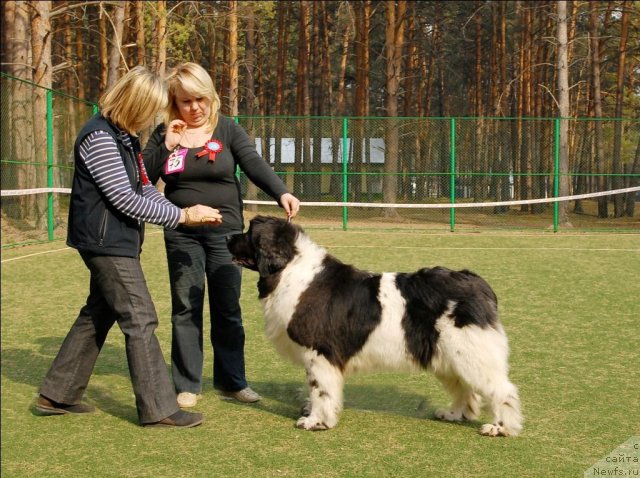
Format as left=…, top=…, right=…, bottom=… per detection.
left=40, top=252, right=179, bottom=423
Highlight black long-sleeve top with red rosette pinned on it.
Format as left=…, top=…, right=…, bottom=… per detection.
left=142, top=116, right=288, bottom=234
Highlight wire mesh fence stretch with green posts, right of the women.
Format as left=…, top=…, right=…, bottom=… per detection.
left=240, top=118, right=640, bottom=231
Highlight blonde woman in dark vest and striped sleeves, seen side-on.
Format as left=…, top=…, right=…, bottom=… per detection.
left=35, top=67, right=221, bottom=427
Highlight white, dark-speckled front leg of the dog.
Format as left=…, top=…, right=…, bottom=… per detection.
left=296, top=352, right=344, bottom=431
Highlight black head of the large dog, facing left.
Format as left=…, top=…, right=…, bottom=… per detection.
left=227, top=216, right=301, bottom=277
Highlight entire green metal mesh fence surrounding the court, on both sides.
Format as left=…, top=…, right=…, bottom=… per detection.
left=0, top=74, right=640, bottom=248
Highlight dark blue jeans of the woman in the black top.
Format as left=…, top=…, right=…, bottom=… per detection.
left=164, top=226, right=247, bottom=394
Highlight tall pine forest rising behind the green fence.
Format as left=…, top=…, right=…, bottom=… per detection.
left=1, top=0, right=640, bottom=229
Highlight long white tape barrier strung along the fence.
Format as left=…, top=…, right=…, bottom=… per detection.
left=2, top=186, right=640, bottom=209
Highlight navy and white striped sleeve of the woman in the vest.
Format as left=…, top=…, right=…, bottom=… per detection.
left=80, top=131, right=180, bottom=229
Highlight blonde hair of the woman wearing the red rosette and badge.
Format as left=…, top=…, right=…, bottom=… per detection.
left=165, top=62, right=220, bottom=130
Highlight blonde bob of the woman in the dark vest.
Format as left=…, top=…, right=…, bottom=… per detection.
left=100, top=66, right=167, bottom=135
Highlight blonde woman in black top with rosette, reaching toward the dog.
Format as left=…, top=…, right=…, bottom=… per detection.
left=143, top=63, right=300, bottom=408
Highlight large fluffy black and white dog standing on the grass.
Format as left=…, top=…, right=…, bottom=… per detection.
left=228, top=216, right=523, bottom=436
